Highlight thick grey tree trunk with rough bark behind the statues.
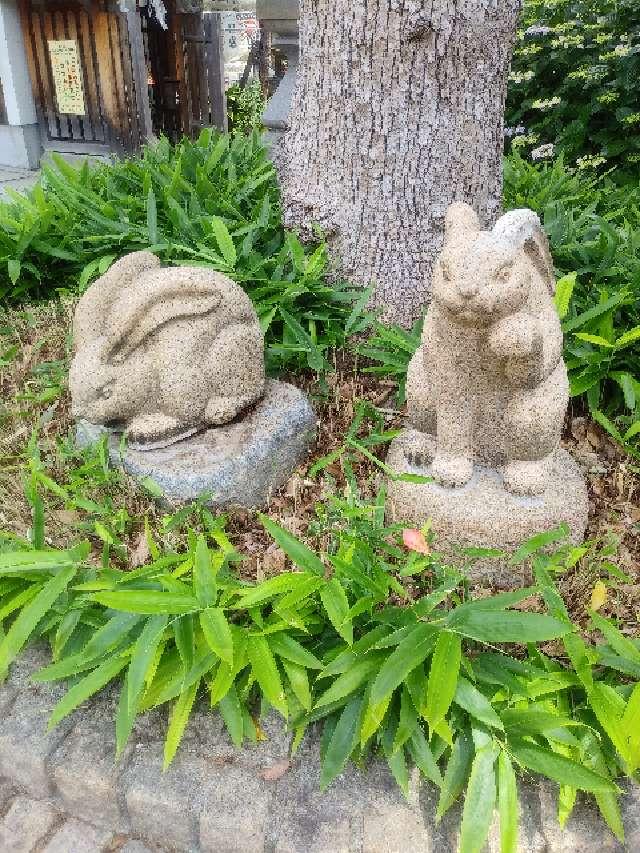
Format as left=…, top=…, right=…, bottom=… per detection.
left=280, top=0, right=520, bottom=325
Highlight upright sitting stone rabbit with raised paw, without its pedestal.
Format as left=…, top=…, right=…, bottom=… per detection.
left=406, top=203, right=568, bottom=495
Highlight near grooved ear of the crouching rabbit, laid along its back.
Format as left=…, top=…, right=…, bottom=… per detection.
left=105, top=267, right=222, bottom=362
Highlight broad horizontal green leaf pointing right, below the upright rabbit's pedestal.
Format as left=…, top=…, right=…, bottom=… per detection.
left=449, top=610, right=573, bottom=645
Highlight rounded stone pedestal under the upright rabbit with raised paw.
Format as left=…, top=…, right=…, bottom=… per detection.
left=387, top=433, right=588, bottom=588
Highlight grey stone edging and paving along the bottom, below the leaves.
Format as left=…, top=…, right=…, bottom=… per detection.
left=0, top=647, right=640, bottom=853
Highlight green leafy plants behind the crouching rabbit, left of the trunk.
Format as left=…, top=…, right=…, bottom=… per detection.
left=0, top=129, right=370, bottom=371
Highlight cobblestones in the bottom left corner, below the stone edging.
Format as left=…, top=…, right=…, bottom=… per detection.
left=0, top=779, right=165, bottom=853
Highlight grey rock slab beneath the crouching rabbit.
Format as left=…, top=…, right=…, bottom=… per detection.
left=76, top=379, right=316, bottom=508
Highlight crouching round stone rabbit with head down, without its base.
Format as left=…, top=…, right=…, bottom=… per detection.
left=69, top=251, right=265, bottom=448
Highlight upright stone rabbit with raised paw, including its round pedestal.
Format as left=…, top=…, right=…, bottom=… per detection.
left=387, top=203, right=588, bottom=586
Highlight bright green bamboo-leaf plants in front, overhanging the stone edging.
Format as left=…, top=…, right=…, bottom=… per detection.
left=0, top=466, right=640, bottom=853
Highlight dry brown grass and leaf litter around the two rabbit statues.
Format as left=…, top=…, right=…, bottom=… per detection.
left=0, top=300, right=640, bottom=633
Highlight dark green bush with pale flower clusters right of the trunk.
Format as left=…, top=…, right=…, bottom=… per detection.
left=506, top=0, right=640, bottom=176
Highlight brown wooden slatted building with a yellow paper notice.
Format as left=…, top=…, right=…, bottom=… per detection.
left=0, top=0, right=226, bottom=167
